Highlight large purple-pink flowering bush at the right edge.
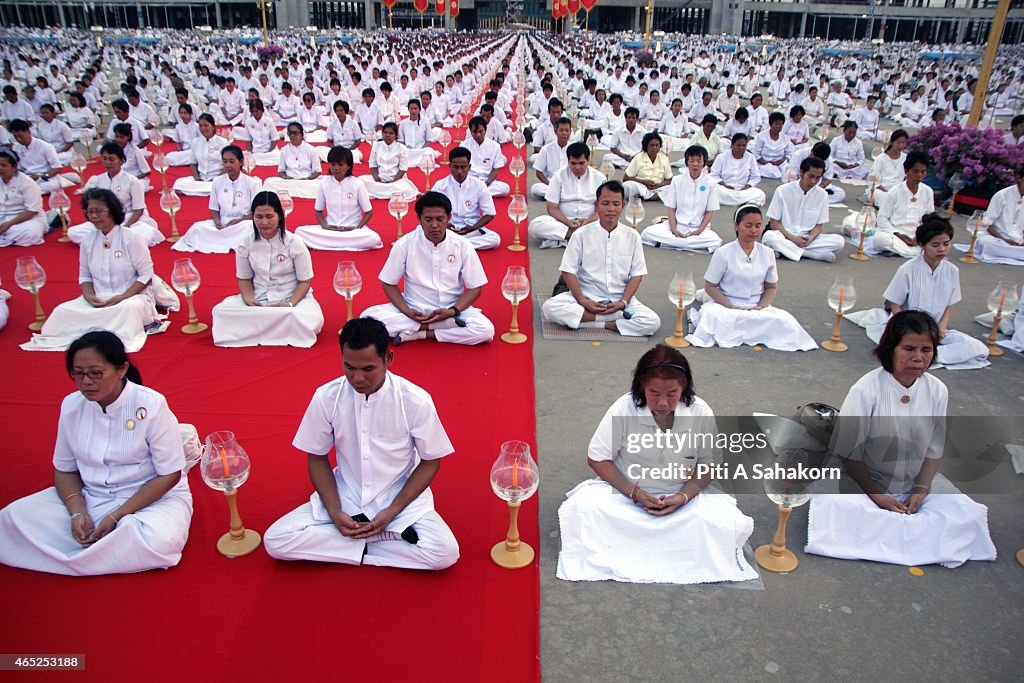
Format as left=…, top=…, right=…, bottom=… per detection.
left=907, top=123, right=1024, bottom=188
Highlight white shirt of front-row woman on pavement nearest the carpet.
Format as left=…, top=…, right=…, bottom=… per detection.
left=587, top=393, right=718, bottom=495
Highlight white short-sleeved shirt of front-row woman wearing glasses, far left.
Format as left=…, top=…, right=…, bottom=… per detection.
left=53, top=382, right=185, bottom=499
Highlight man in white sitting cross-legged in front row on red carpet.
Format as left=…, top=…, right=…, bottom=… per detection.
left=263, top=317, right=459, bottom=569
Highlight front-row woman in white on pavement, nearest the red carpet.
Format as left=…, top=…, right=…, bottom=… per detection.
left=557, top=344, right=758, bottom=584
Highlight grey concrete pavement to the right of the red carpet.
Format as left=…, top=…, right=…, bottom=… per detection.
left=530, top=136, right=1024, bottom=681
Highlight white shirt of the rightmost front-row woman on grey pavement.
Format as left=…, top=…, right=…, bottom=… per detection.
left=830, top=368, right=949, bottom=495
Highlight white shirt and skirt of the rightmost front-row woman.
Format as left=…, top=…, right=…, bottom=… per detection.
left=805, top=370, right=995, bottom=567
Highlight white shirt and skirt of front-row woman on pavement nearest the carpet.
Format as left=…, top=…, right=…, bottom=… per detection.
left=557, top=393, right=758, bottom=584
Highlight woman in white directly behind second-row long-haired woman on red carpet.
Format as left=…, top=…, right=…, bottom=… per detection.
left=171, top=144, right=262, bottom=254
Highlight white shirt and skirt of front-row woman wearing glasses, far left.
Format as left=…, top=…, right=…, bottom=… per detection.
left=0, top=382, right=193, bottom=577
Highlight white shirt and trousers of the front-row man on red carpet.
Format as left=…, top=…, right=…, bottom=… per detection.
left=263, top=373, right=459, bottom=569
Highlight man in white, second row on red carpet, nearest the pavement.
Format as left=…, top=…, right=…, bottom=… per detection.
left=362, top=191, right=495, bottom=345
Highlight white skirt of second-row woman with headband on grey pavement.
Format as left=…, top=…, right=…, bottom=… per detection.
left=686, top=301, right=818, bottom=351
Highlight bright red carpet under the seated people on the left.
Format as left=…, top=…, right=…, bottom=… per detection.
left=0, top=136, right=540, bottom=681
